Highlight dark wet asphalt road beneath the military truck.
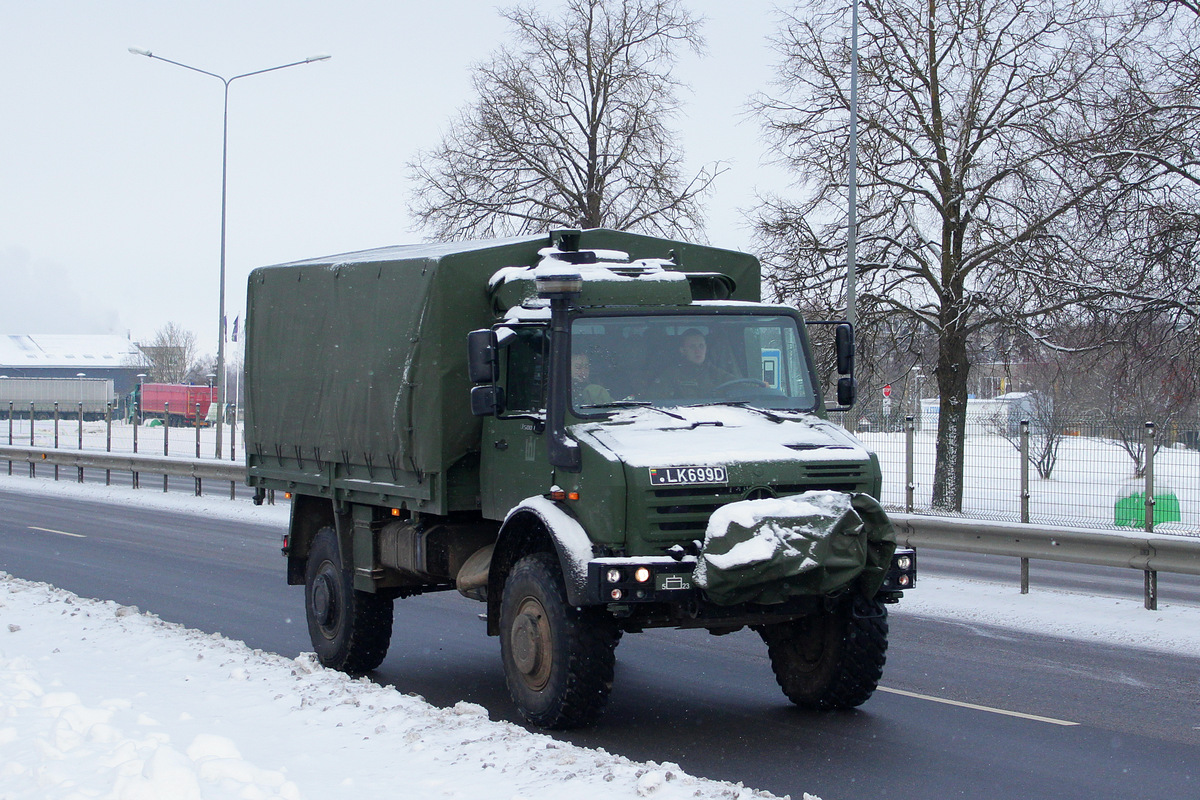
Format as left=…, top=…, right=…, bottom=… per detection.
left=0, top=483, right=1200, bottom=800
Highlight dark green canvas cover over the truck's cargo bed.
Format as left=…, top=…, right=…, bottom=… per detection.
left=246, top=229, right=758, bottom=512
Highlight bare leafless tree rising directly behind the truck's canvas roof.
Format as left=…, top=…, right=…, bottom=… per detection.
left=409, top=0, right=720, bottom=239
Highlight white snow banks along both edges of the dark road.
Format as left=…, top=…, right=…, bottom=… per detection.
left=0, top=475, right=1200, bottom=800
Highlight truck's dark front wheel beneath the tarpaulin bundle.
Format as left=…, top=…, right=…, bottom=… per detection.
left=757, top=599, right=888, bottom=710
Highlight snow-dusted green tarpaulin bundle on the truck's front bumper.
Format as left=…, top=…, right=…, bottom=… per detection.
left=694, top=492, right=895, bottom=606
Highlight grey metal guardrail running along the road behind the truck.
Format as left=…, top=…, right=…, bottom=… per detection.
left=0, top=445, right=1200, bottom=609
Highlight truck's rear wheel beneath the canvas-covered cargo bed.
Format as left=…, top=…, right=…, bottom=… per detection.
left=304, top=528, right=392, bottom=675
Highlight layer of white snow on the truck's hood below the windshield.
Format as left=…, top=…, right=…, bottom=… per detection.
left=571, top=405, right=870, bottom=467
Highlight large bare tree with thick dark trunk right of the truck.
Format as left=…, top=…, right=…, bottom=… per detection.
left=756, top=0, right=1164, bottom=510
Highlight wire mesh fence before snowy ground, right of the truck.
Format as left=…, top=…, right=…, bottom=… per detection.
left=853, top=407, right=1200, bottom=535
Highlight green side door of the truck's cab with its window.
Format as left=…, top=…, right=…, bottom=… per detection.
left=480, top=325, right=553, bottom=519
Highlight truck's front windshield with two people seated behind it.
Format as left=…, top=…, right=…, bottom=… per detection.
left=571, top=314, right=816, bottom=415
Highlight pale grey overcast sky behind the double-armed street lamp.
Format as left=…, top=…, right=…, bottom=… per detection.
left=0, top=0, right=806, bottom=353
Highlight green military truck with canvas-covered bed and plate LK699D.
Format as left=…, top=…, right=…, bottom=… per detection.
left=245, top=229, right=916, bottom=728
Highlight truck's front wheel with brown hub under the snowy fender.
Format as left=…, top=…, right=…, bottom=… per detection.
left=500, top=553, right=619, bottom=729
